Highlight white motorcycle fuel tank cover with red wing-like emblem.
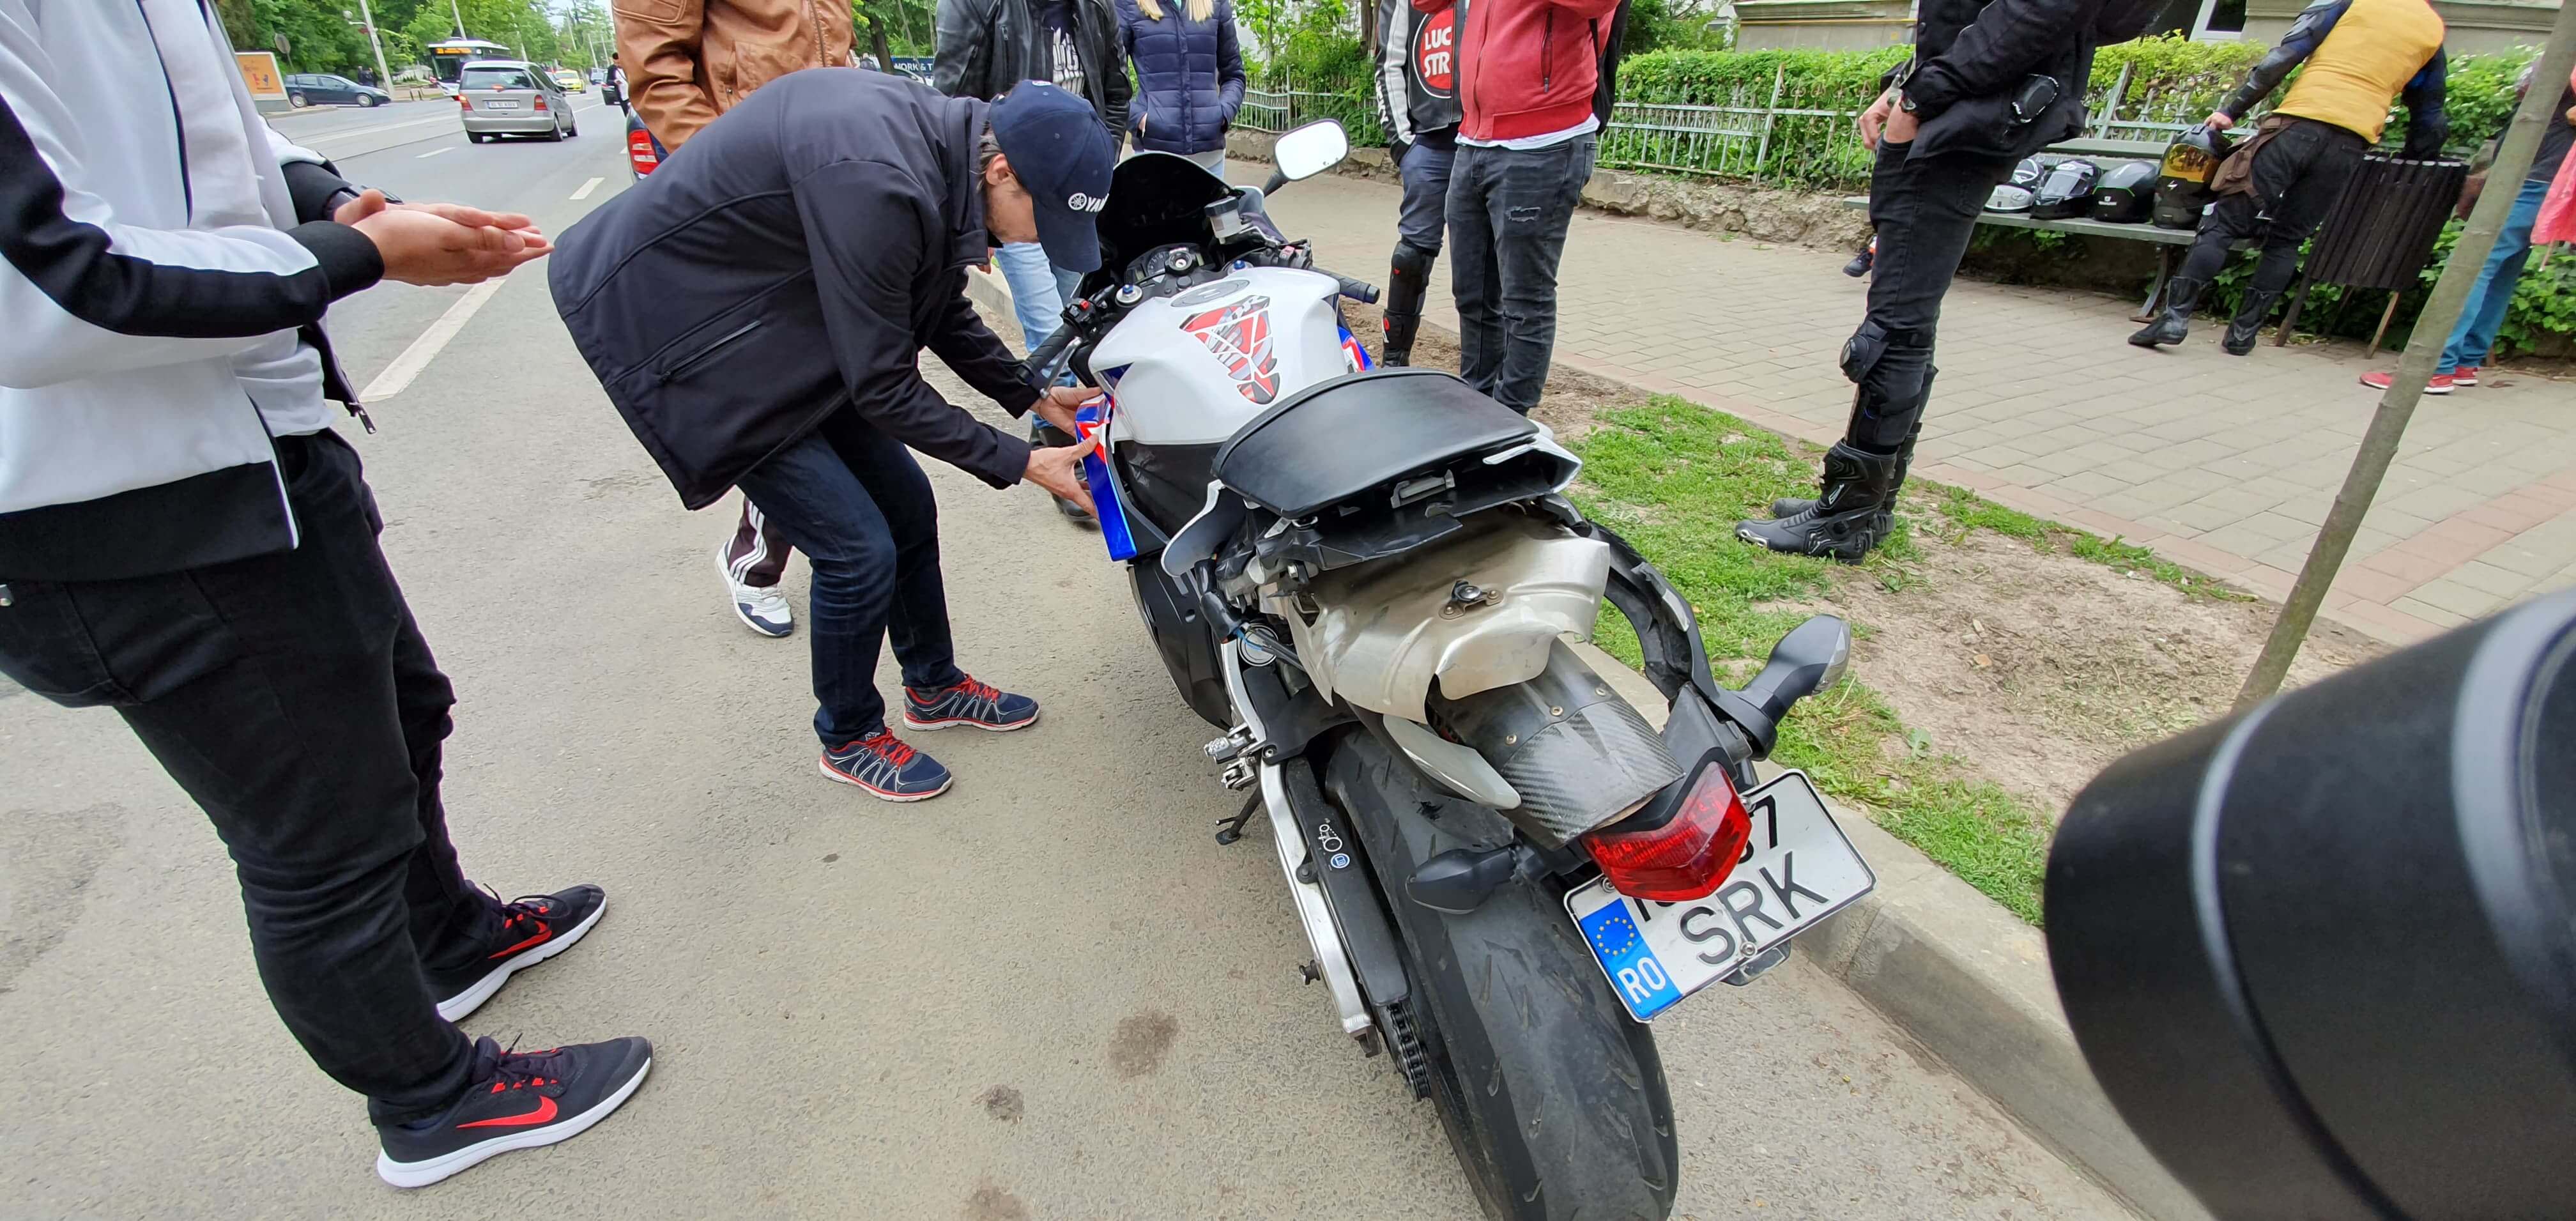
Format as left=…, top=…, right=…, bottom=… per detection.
left=1092, top=268, right=1350, bottom=445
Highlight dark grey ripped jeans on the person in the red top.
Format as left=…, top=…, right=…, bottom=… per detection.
left=1448, top=137, right=1600, bottom=415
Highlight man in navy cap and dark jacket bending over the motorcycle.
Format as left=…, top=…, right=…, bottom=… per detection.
left=549, top=67, right=1118, bottom=801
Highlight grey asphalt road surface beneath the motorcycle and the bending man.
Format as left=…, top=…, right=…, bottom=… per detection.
left=0, top=107, right=2125, bottom=1221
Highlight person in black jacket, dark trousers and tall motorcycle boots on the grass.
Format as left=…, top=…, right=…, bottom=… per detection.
left=1736, top=0, right=2104, bottom=562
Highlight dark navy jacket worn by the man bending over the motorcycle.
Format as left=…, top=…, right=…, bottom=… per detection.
left=546, top=67, right=1038, bottom=507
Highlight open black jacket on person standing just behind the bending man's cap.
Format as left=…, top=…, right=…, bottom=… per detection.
left=930, top=0, right=1131, bottom=142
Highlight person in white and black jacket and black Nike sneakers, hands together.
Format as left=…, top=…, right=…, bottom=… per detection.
left=0, top=0, right=652, bottom=1188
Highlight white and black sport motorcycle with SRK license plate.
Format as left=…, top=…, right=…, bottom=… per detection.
left=1031, top=121, right=1875, bottom=1218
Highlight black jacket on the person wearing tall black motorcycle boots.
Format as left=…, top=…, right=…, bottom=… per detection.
left=1899, top=0, right=2104, bottom=160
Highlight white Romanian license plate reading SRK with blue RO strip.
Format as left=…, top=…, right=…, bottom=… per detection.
left=1566, top=772, right=1878, bottom=1023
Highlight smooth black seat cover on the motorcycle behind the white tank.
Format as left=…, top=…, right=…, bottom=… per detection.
left=1216, top=369, right=1538, bottom=518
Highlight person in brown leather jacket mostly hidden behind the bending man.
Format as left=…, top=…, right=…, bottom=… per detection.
left=616, top=0, right=855, bottom=636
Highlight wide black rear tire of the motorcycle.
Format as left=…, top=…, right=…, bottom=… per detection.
left=1332, top=734, right=1682, bottom=1221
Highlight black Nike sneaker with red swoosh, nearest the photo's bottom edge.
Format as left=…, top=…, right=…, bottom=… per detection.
left=376, top=1038, right=652, bottom=1188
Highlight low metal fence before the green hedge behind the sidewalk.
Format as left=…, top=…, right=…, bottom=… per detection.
left=1234, top=67, right=2207, bottom=185
